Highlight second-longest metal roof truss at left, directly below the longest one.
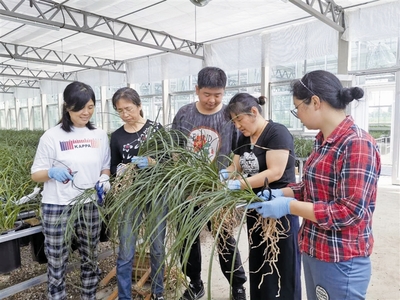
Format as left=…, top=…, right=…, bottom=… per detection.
left=0, top=42, right=125, bottom=73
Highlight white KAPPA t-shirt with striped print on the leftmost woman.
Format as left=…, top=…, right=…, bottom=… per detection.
left=31, top=124, right=110, bottom=205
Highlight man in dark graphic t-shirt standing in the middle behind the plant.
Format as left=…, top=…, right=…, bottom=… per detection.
left=172, top=67, right=247, bottom=300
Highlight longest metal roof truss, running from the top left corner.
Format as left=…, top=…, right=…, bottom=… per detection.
left=0, top=0, right=203, bottom=59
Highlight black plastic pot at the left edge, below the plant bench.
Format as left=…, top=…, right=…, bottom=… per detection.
left=0, top=222, right=22, bottom=274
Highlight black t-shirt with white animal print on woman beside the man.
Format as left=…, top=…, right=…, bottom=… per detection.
left=234, top=120, right=296, bottom=193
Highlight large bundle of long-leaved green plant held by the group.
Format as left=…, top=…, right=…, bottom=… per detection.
left=106, top=130, right=290, bottom=298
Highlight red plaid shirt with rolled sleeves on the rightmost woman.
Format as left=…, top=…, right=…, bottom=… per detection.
left=289, top=116, right=381, bottom=262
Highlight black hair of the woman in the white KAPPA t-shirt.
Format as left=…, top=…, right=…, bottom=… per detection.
left=58, top=81, right=96, bottom=132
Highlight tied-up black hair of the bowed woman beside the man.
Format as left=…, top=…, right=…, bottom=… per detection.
left=224, top=93, right=267, bottom=120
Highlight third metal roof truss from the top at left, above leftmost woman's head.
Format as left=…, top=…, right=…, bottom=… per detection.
left=0, top=64, right=76, bottom=81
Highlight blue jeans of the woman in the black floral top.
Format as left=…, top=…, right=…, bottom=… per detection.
left=117, top=201, right=167, bottom=300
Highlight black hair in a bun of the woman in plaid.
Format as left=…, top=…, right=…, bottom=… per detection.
left=291, top=70, right=364, bottom=109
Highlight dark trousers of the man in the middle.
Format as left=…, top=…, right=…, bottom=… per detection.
left=181, top=206, right=247, bottom=287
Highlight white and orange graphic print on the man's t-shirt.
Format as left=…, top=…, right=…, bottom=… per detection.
left=187, top=127, right=221, bottom=161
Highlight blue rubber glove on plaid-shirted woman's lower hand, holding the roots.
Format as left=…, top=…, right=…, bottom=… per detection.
left=247, top=197, right=296, bottom=219
